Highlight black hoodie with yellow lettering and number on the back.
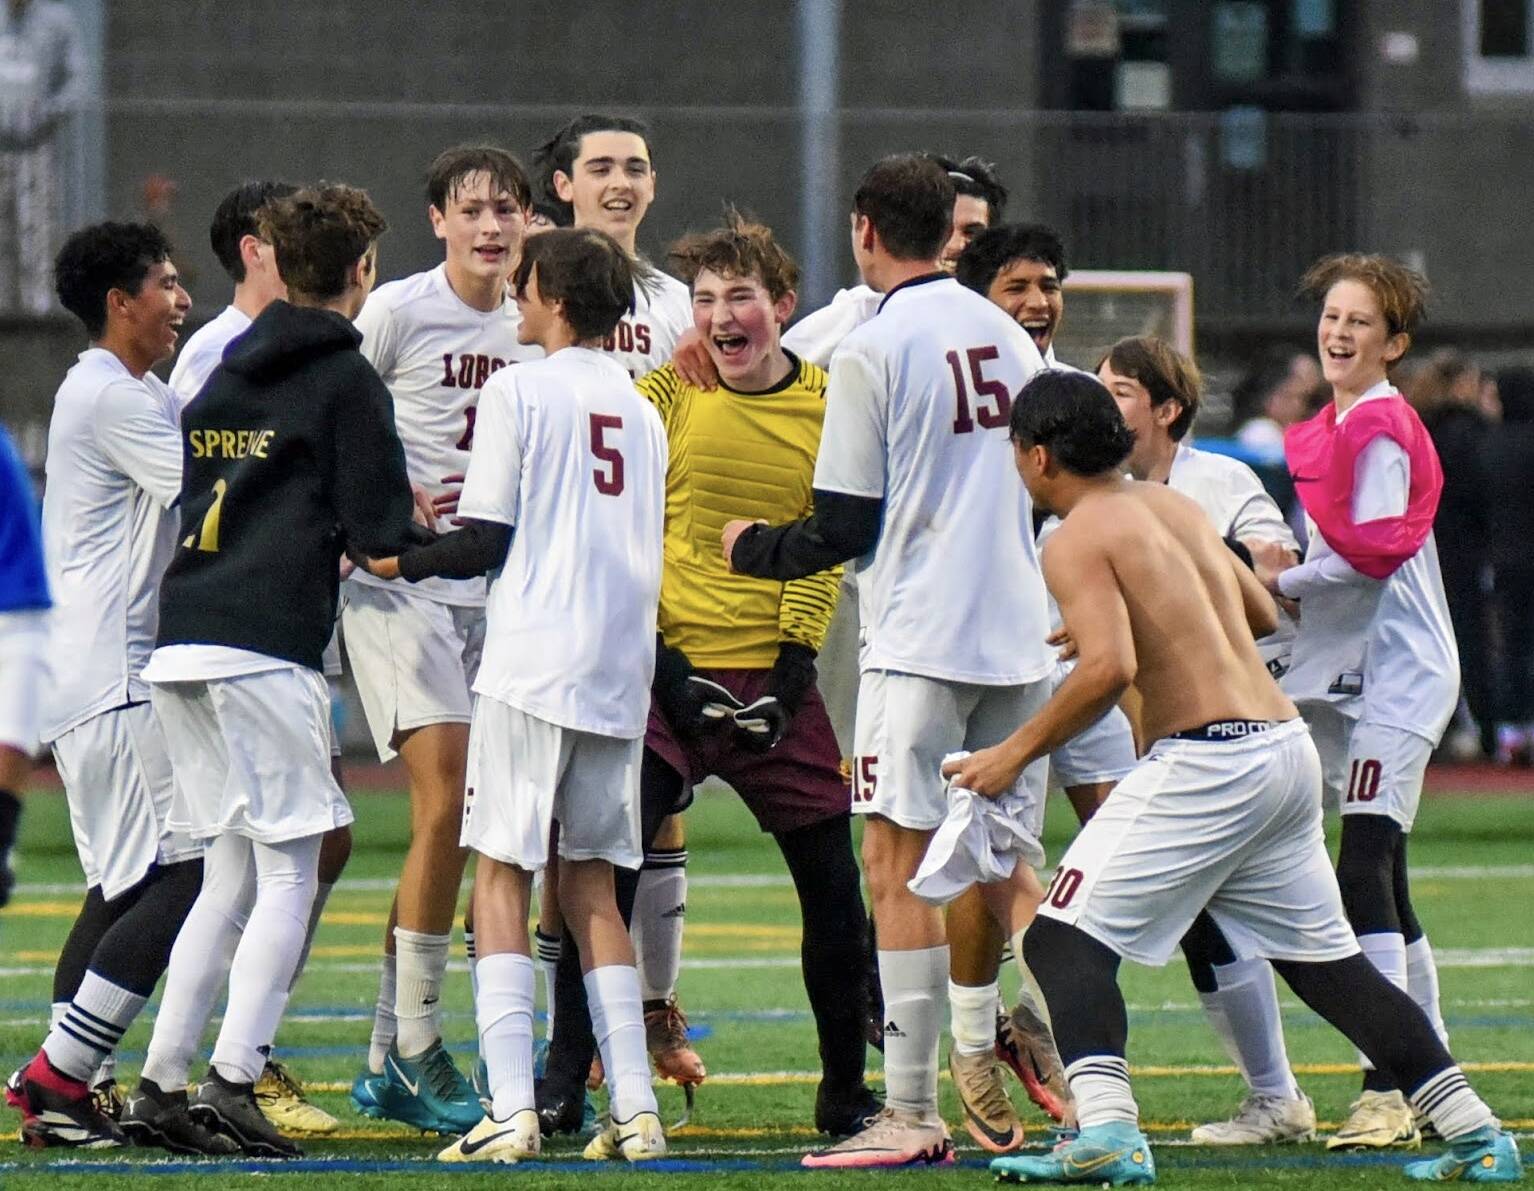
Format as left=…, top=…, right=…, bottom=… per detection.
left=158, top=301, right=416, bottom=671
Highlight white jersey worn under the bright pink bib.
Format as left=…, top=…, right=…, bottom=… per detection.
left=1278, top=382, right=1459, bottom=743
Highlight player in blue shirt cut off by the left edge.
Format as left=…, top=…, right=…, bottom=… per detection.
left=0, top=427, right=54, bottom=906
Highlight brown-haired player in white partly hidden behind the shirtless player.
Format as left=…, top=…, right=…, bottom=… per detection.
left=1097, top=336, right=1316, bottom=1145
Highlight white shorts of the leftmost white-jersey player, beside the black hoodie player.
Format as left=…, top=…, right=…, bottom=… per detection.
left=54, top=703, right=202, bottom=901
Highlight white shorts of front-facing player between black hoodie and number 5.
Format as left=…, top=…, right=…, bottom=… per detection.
left=341, top=582, right=485, bottom=761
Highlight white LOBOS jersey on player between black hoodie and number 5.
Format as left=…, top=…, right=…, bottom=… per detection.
left=353, top=264, right=543, bottom=605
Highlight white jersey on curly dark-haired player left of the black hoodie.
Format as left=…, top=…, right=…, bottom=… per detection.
left=41, top=347, right=181, bottom=741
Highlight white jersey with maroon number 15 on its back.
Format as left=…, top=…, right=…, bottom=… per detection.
left=815, top=276, right=1054, bottom=686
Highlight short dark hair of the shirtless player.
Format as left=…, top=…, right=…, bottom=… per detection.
left=1009, top=368, right=1135, bottom=476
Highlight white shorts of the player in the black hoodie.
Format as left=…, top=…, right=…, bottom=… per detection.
left=153, top=666, right=351, bottom=844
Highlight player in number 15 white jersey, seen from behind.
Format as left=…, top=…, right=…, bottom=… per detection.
left=723, top=155, right=1052, bottom=1166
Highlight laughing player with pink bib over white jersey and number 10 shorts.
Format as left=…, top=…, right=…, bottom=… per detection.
left=1270, top=253, right=1459, bottom=1148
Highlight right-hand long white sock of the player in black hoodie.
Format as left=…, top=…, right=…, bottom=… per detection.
left=213, top=835, right=324, bottom=1084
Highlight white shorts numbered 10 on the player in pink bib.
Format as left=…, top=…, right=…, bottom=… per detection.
left=1304, top=703, right=1433, bottom=832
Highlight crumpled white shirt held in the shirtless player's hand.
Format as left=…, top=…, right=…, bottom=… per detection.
left=905, top=752, right=1045, bottom=906
